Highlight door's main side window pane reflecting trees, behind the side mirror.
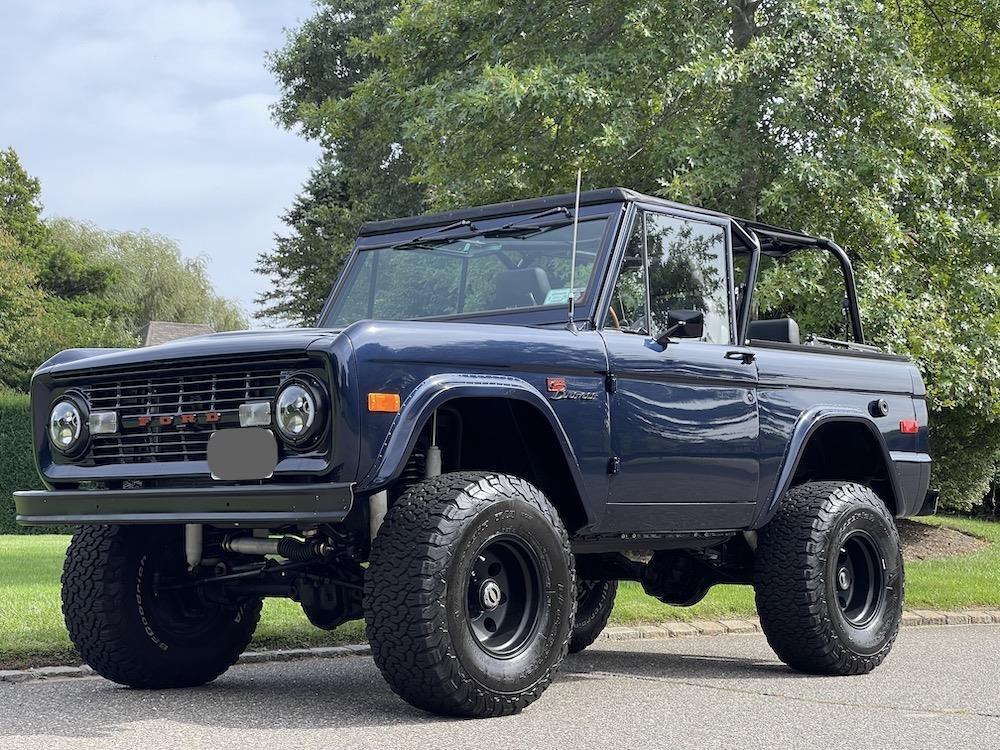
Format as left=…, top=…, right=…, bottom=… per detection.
left=646, top=213, right=731, bottom=344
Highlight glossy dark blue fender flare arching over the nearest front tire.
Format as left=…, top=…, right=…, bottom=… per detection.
left=359, top=373, right=588, bottom=520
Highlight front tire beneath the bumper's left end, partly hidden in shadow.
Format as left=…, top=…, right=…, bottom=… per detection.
left=62, top=526, right=261, bottom=688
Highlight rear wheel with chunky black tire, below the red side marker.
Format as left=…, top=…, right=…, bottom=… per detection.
left=755, top=482, right=903, bottom=675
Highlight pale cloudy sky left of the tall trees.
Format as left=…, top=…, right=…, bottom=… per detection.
left=0, top=0, right=318, bottom=324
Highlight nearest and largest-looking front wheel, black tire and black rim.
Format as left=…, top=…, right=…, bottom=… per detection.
left=365, top=473, right=576, bottom=717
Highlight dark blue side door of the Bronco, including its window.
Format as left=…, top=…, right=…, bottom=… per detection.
left=602, top=210, right=759, bottom=531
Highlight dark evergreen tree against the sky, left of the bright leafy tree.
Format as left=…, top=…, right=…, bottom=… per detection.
left=255, top=0, right=423, bottom=325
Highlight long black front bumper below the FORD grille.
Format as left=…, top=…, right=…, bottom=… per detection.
left=14, top=484, right=354, bottom=526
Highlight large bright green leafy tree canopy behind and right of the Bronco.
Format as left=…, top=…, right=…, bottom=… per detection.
left=264, top=0, right=1000, bottom=507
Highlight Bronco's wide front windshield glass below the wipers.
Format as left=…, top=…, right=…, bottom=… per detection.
left=323, top=217, right=608, bottom=327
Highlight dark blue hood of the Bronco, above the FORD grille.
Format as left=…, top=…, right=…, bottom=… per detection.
left=36, top=328, right=340, bottom=374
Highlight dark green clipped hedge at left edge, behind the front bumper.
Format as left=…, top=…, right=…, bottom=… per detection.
left=0, top=392, right=45, bottom=534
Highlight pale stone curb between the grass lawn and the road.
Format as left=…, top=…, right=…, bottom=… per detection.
left=0, top=609, right=1000, bottom=683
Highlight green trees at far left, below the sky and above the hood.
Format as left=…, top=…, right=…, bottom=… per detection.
left=0, top=149, right=246, bottom=390
